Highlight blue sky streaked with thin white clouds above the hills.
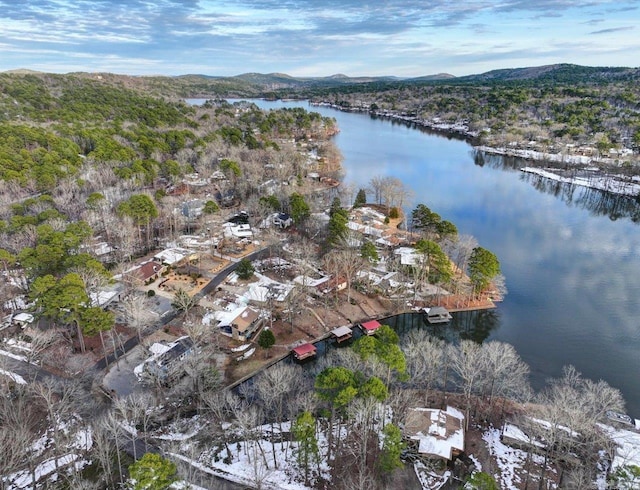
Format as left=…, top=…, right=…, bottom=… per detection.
left=0, top=0, right=640, bottom=77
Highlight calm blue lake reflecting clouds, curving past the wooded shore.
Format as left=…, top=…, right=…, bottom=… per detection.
left=190, top=97, right=640, bottom=417
